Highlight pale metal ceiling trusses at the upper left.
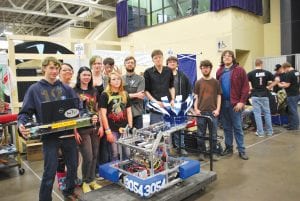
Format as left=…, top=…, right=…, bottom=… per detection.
left=0, top=0, right=117, bottom=35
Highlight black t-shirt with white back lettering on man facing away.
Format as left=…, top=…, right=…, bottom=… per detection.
left=248, top=69, right=274, bottom=97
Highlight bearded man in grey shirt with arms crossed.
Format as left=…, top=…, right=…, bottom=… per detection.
left=123, top=56, right=145, bottom=128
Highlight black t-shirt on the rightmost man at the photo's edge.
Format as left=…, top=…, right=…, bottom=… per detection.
left=285, top=70, right=300, bottom=96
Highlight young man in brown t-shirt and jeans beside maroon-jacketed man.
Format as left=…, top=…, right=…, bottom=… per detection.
left=194, top=60, right=221, bottom=161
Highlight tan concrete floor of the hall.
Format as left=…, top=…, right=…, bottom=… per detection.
left=0, top=127, right=300, bottom=201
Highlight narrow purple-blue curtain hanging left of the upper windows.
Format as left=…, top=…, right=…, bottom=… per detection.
left=116, top=0, right=128, bottom=37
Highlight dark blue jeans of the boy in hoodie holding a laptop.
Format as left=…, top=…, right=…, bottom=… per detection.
left=39, top=136, right=78, bottom=201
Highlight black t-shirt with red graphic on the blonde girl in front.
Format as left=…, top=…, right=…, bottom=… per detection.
left=99, top=91, right=131, bottom=132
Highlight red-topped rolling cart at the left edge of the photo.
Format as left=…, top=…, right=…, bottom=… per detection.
left=0, top=114, right=25, bottom=175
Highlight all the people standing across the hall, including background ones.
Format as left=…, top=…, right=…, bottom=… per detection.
left=18, top=50, right=299, bottom=201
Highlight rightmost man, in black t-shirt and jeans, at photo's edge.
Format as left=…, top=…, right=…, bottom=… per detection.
left=278, top=62, right=300, bottom=130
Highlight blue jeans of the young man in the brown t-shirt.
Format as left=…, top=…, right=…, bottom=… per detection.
left=197, top=112, right=218, bottom=153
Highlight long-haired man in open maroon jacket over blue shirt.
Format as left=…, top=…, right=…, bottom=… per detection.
left=217, top=50, right=249, bottom=160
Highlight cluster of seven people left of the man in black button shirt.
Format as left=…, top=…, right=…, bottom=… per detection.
left=18, top=56, right=144, bottom=201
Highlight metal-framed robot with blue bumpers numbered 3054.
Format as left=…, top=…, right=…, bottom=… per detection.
left=99, top=122, right=200, bottom=197
